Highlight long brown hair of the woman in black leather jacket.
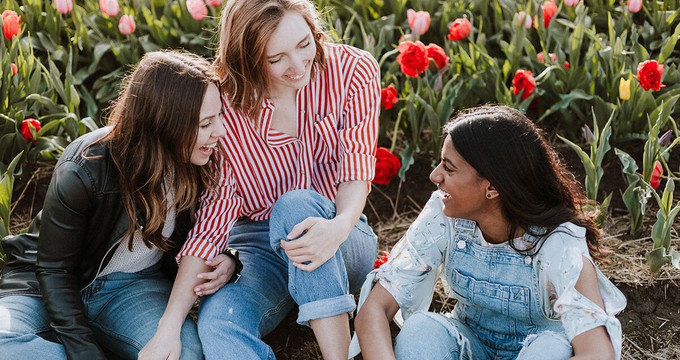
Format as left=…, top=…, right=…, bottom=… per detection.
left=101, top=51, right=218, bottom=251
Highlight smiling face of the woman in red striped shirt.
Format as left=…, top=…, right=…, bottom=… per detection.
left=265, top=11, right=316, bottom=96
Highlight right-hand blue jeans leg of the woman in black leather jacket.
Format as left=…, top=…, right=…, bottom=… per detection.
left=82, top=263, right=203, bottom=359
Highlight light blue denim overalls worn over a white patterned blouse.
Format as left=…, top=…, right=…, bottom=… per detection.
left=395, top=219, right=572, bottom=360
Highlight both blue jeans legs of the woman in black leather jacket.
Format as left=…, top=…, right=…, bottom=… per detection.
left=0, top=265, right=203, bottom=359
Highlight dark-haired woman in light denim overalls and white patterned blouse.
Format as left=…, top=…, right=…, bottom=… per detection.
left=353, top=106, right=626, bottom=360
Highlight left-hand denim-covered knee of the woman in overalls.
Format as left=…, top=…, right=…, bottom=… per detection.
left=394, top=312, right=460, bottom=359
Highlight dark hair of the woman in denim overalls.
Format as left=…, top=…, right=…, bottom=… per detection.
left=444, top=105, right=601, bottom=258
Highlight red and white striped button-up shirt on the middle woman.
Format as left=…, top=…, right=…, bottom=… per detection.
left=177, top=44, right=380, bottom=259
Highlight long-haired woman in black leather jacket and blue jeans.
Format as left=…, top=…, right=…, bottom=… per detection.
left=0, top=51, right=233, bottom=359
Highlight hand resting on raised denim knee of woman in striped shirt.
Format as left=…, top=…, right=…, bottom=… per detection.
left=281, top=217, right=352, bottom=272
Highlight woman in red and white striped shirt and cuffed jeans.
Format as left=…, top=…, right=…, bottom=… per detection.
left=144, top=0, right=380, bottom=360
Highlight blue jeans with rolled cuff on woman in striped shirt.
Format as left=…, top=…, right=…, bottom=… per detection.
left=198, top=190, right=377, bottom=360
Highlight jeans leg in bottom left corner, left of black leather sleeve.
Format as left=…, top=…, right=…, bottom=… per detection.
left=0, top=295, right=66, bottom=360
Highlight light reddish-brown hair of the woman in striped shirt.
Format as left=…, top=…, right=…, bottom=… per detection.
left=214, top=0, right=326, bottom=124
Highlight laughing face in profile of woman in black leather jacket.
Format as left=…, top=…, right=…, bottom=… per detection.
left=191, top=84, right=226, bottom=166
